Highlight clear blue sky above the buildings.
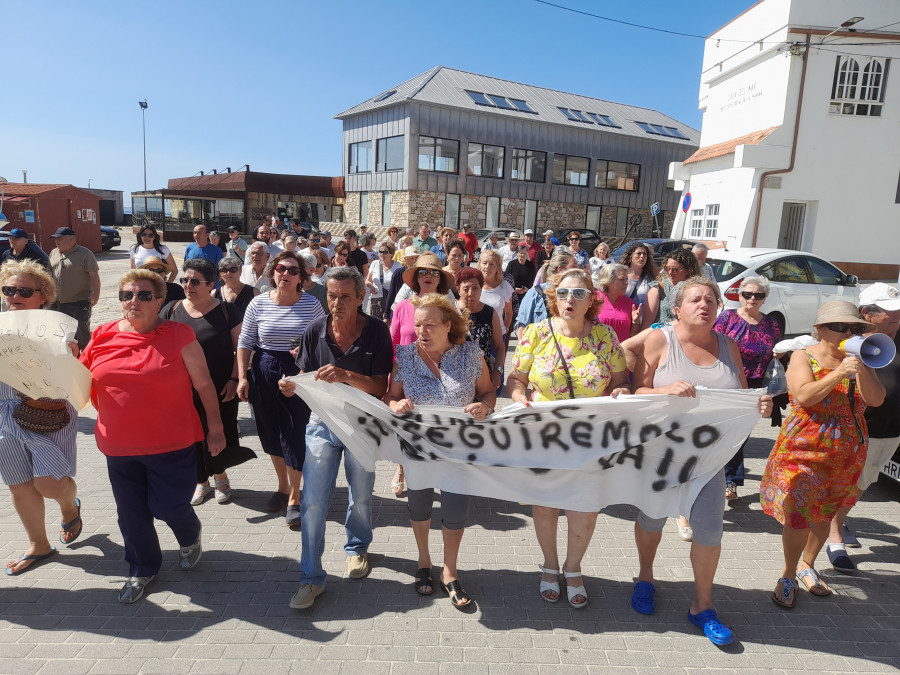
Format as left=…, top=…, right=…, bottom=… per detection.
left=0, top=0, right=753, bottom=201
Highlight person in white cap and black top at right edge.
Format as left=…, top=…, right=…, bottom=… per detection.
left=827, top=283, right=900, bottom=572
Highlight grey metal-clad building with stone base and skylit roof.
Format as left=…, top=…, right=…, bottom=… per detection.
left=335, top=66, right=700, bottom=239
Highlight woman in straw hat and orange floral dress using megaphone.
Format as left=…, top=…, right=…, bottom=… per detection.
left=760, top=300, right=885, bottom=608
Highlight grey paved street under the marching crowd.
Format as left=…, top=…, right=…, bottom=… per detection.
left=0, top=245, right=900, bottom=675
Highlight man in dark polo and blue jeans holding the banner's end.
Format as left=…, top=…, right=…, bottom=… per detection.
left=279, top=267, right=393, bottom=609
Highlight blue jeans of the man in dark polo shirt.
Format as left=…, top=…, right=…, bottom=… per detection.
left=300, top=415, right=375, bottom=586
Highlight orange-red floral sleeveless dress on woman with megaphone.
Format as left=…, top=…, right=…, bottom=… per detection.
left=759, top=351, right=869, bottom=529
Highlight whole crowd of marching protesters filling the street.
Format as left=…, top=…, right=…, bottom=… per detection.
left=0, top=220, right=900, bottom=645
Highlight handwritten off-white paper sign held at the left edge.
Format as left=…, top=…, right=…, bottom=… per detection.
left=0, top=309, right=91, bottom=410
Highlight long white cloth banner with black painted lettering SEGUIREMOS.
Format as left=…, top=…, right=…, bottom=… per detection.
left=288, top=373, right=764, bottom=518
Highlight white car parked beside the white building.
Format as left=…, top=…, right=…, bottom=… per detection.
left=706, top=248, right=859, bottom=335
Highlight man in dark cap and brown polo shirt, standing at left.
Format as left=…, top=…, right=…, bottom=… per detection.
left=49, top=227, right=100, bottom=349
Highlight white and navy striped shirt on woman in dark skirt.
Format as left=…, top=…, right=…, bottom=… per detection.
left=238, top=293, right=325, bottom=352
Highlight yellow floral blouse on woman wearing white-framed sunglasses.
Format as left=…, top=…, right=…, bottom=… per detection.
left=513, top=319, right=626, bottom=401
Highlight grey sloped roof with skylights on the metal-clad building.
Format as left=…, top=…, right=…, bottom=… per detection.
left=335, top=66, right=700, bottom=145
